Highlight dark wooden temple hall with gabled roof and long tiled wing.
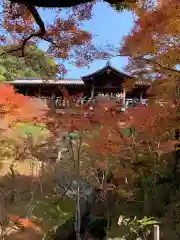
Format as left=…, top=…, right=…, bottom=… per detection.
left=12, top=62, right=150, bottom=105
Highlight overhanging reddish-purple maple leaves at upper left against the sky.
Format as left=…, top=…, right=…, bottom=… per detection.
left=0, top=0, right=141, bottom=73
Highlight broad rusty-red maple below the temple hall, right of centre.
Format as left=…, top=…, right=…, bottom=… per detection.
left=50, top=95, right=178, bottom=219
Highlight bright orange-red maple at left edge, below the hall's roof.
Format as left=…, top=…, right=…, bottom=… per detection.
left=0, top=84, right=48, bottom=170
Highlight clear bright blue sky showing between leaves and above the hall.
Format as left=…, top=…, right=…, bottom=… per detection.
left=39, top=2, right=133, bottom=79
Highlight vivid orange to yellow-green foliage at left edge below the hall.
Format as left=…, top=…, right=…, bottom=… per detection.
left=0, top=85, right=49, bottom=174
